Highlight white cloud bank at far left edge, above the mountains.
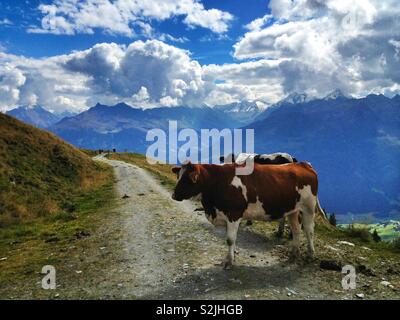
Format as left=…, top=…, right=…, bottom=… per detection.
left=0, top=52, right=89, bottom=111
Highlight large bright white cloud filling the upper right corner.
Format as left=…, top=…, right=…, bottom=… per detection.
left=234, top=0, right=400, bottom=96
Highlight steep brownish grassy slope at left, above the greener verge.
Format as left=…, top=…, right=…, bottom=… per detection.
left=0, top=113, right=107, bottom=227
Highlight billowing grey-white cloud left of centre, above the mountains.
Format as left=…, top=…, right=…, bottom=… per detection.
left=64, top=40, right=204, bottom=105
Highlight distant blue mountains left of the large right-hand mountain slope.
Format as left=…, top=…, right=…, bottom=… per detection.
left=48, top=103, right=261, bottom=153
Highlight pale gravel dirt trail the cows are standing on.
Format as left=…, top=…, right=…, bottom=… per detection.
left=90, top=157, right=360, bottom=299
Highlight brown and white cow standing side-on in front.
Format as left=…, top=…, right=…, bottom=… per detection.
left=172, top=162, right=321, bottom=269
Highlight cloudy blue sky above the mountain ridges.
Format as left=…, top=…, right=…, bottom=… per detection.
left=0, top=0, right=400, bottom=112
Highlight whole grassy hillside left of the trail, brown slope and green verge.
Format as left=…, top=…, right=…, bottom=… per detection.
left=0, top=113, right=116, bottom=298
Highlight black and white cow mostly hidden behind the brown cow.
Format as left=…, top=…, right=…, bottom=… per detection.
left=219, top=152, right=297, bottom=234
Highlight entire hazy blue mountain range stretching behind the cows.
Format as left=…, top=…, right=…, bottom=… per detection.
left=3, top=90, right=400, bottom=218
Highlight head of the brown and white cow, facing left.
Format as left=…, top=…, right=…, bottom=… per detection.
left=172, top=162, right=201, bottom=201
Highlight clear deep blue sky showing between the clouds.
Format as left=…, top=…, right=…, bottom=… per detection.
left=0, top=0, right=270, bottom=64
